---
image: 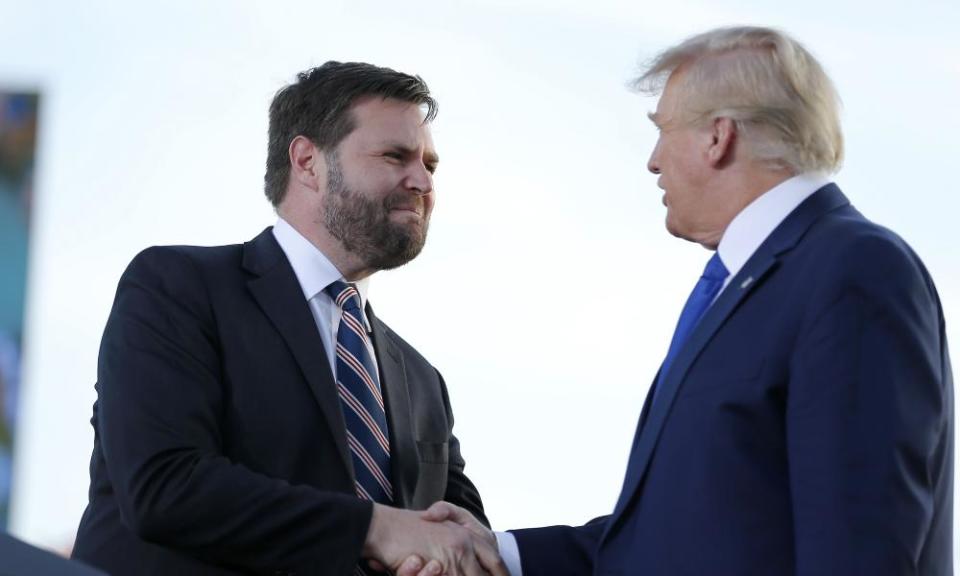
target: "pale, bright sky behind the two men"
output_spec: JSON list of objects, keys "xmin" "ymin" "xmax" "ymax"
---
[{"xmin": 0, "ymin": 0, "xmax": 960, "ymax": 564}]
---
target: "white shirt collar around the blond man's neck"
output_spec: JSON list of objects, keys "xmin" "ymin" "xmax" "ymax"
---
[{"xmin": 717, "ymin": 172, "xmax": 830, "ymax": 281}]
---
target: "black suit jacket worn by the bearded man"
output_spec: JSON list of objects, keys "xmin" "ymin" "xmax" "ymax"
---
[{"xmin": 74, "ymin": 229, "xmax": 486, "ymax": 576}]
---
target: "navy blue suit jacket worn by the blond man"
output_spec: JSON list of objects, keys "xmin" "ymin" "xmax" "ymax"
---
[{"xmin": 515, "ymin": 184, "xmax": 953, "ymax": 576}]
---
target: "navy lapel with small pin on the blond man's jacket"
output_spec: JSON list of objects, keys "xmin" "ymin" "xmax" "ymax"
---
[{"xmin": 607, "ymin": 184, "xmax": 849, "ymax": 533}]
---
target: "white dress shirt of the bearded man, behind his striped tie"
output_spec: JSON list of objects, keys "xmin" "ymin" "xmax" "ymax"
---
[{"xmin": 273, "ymin": 218, "xmax": 380, "ymax": 376}]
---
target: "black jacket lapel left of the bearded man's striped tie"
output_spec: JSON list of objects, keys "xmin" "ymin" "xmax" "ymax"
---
[{"xmin": 243, "ymin": 228, "xmax": 353, "ymax": 476}]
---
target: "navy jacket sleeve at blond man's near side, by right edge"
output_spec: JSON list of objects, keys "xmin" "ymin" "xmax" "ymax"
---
[{"xmin": 786, "ymin": 235, "xmax": 953, "ymax": 576}]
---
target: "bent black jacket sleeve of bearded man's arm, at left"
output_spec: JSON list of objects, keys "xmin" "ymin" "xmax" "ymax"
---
[{"xmin": 97, "ymin": 248, "xmax": 371, "ymax": 576}]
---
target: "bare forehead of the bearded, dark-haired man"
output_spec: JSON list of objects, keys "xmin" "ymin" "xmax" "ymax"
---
[{"xmin": 347, "ymin": 98, "xmax": 433, "ymax": 148}]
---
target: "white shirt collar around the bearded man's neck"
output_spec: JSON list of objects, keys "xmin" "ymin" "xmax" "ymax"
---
[{"xmin": 273, "ymin": 218, "xmax": 370, "ymax": 310}]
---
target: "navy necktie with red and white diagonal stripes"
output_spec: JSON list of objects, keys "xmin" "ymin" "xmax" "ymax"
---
[{"xmin": 326, "ymin": 280, "xmax": 393, "ymax": 504}]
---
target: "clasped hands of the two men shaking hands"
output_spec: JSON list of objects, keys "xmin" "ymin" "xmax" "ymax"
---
[{"xmin": 361, "ymin": 502, "xmax": 510, "ymax": 576}]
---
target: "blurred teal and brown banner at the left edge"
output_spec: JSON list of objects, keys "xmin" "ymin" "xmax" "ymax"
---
[{"xmin": 0, "ymin": 89, "xmax": 39, "ymax": 532}]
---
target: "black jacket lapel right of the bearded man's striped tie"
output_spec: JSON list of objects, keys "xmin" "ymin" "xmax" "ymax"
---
[{"xmin": 366, "ymin": 303, "xmax": 418, "ymax": 506}]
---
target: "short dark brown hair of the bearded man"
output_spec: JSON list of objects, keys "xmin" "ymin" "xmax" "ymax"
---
[{"xmin": 263, "ymin": 61, "xmax": 437, "ymax": 206}]
